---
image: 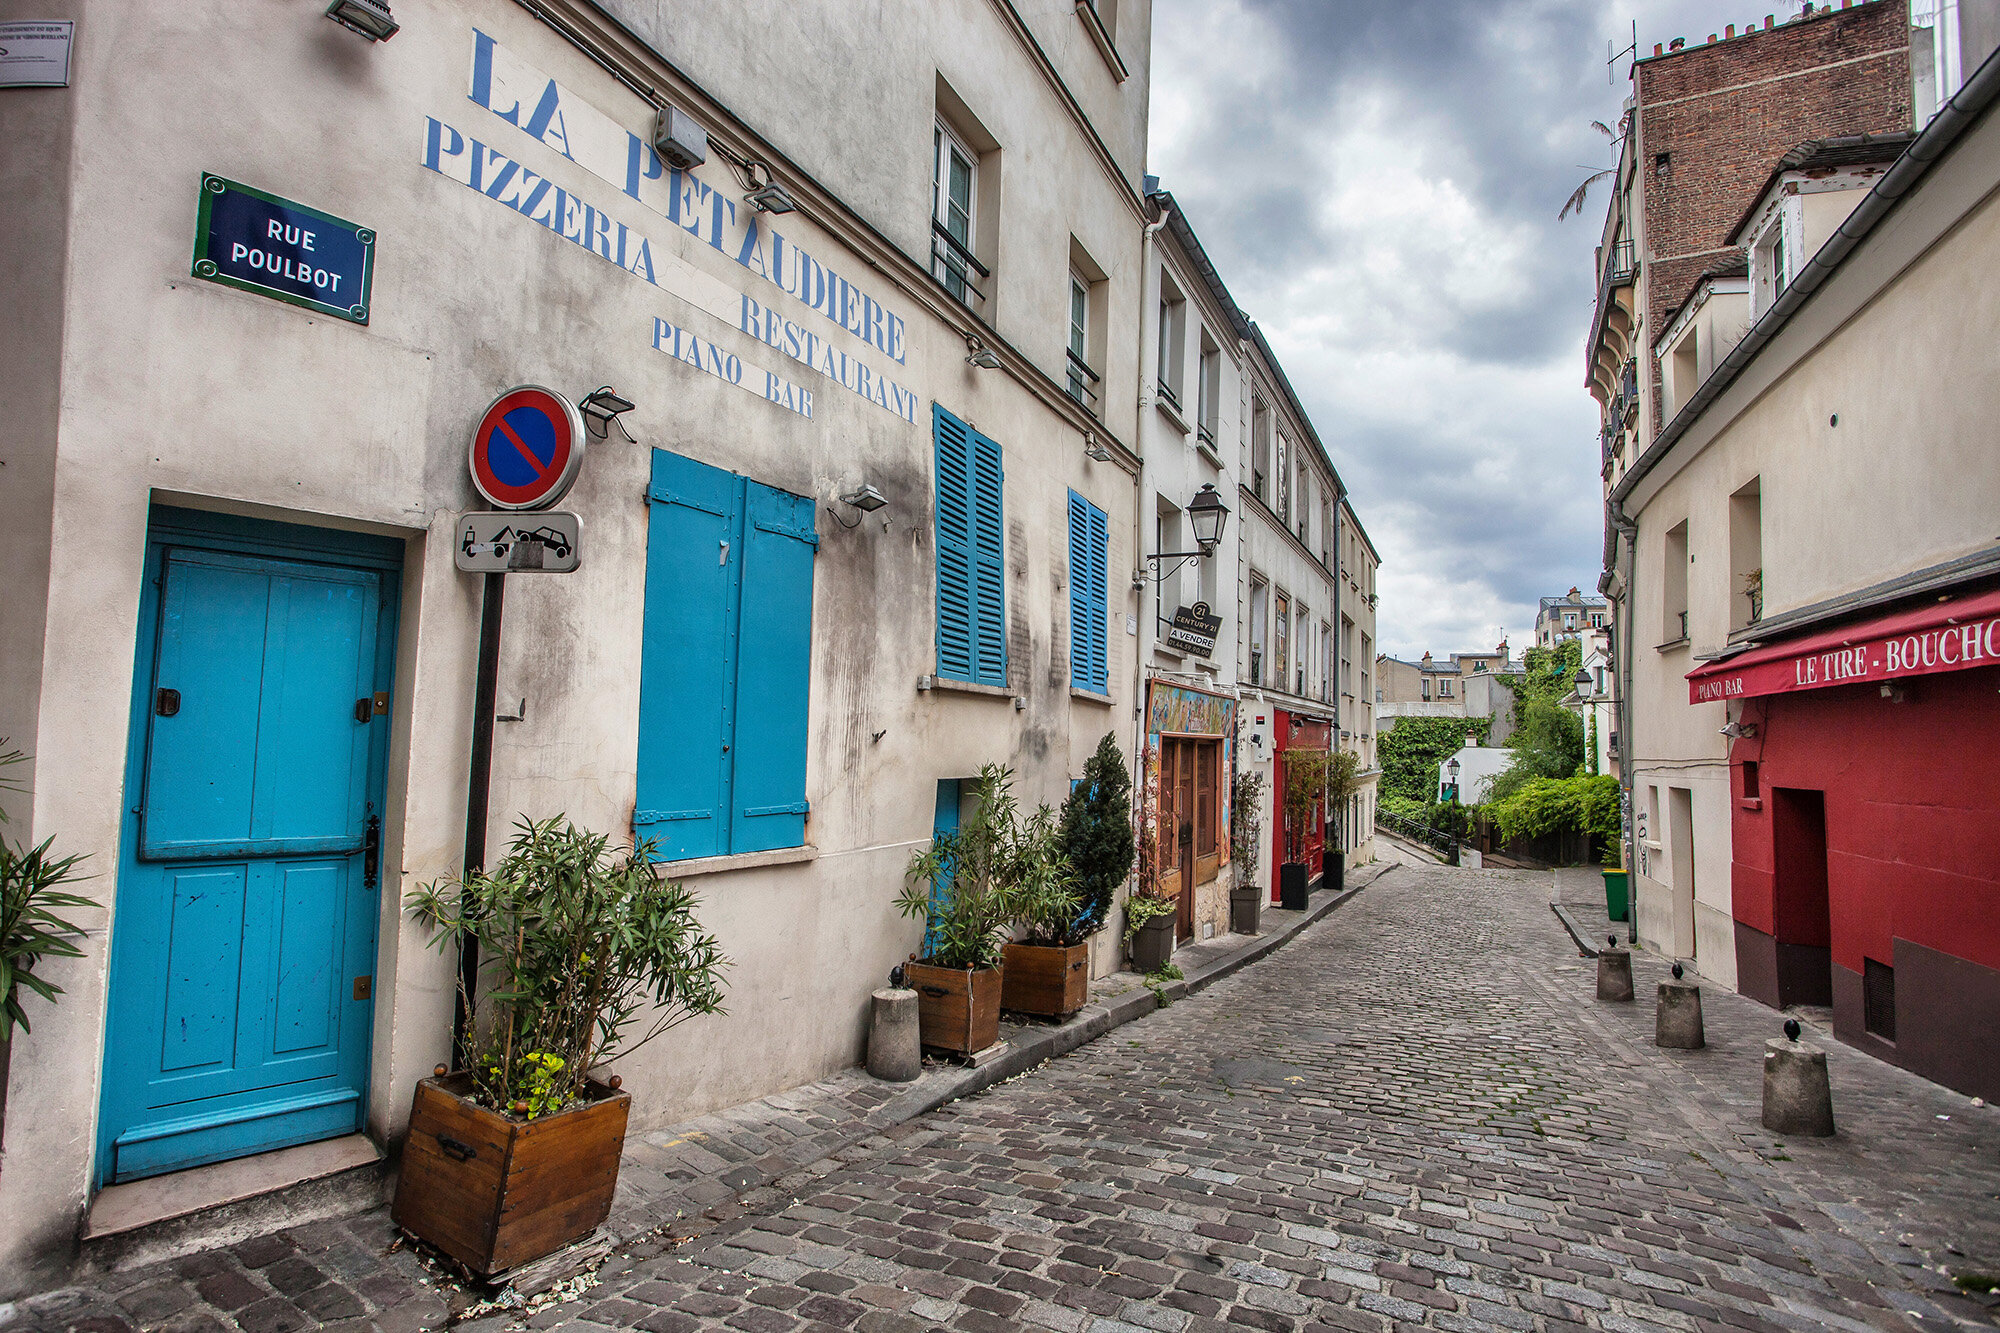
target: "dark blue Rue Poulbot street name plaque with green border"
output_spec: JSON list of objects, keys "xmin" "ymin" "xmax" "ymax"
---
[{"xmin": 194, "ymin": 172, "xmax": 374, "ymax": 324}]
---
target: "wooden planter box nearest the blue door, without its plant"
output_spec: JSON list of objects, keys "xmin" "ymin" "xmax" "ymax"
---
[{"xmin": 390, "ymin": 1075, "xmax": 632, "ymax": 1277}]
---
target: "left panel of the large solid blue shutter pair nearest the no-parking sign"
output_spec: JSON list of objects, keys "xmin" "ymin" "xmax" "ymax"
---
[{"xmin": 632, "ymin": 448, "xmax": 742, "ymax": 861}]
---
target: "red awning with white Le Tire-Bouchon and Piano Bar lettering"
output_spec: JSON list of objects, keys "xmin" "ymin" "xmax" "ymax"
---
[{"xmin": 1688, "ymin": 588, "xmax": 2000, "ymax": 703}]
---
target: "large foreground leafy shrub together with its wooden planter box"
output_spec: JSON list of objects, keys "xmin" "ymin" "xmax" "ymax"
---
[{"xmin": 392, "ymin": 815, "xmax": 728, "ymax": 1277}]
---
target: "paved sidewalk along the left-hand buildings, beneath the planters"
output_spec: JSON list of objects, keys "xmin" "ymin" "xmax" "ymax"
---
[{"xmin": 0, "ymin": 861, "xmax": 1398, "ymax": 1333}]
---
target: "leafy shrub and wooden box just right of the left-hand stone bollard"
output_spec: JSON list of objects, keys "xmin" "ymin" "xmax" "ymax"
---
[{"xmin": 912, "ymin": 765, "xmax": 1046, "ymax": 1057}]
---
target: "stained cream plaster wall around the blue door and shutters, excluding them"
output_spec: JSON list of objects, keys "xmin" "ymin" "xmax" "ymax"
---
[{"xmin": 0, "ymin": 0, "xmax": 1144, "ymax": 1295}]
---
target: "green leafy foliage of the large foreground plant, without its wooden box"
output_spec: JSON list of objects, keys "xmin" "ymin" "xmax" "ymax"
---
[{"xmin": 406, "ymin": 815, "xmax": 730, "ymax": 1119}]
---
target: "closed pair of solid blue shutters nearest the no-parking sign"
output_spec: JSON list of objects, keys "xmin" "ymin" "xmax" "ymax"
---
[{"xmin": 632, "ymin": 448, "xmax": 820, "ymax": 861}]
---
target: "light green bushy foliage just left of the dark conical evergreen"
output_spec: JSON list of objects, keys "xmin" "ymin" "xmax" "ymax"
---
[{"xmin": 896, "ymin": 765, "xmax": 1080, "ymax": 971}]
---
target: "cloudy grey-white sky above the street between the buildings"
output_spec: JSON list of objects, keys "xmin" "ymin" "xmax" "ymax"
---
[{"xmin": 1150, "ymin": 0, "xmax": 1796, "ymax": 656}]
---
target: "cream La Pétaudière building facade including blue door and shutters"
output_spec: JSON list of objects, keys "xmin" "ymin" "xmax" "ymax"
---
[{"xmin": 0, "ymin": 0, "xmax": 1152, "ymax": 1299}]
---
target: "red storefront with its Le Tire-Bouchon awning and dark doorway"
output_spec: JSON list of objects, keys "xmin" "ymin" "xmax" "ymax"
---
[{"xmin": 1688, "ymin": 586, "xmax": 2000, "ymax": 1099}]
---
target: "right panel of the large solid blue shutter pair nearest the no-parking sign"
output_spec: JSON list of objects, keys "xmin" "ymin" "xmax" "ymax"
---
[{"xmin": 730, "ymin": 480, "xmax": 820, "ymax": 853}]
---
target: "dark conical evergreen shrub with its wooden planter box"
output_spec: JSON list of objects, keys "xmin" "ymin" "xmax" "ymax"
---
[{"xmin": 1000, "ymin": 733, "xmax": 1134, "ymax": 1017}]
